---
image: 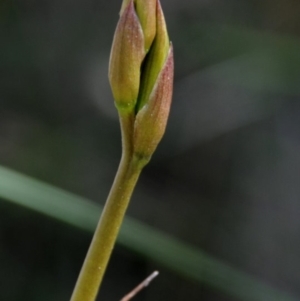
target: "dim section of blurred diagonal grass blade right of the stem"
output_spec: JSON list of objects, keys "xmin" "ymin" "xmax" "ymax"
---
[{"xmin": 119, "ymin": 219, "xmax": 298, "ymax": 301}]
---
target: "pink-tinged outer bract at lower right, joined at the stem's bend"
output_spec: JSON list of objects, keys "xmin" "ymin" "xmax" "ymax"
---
[{"xmin": 133, "ymin": 45, "xmax": 174, "ymax": 163}]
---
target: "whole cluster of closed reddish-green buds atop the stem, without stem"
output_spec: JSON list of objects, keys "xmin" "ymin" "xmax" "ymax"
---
[{"xmin": 109, "ymin": 0, "xmax": 174, "ymax": 163}]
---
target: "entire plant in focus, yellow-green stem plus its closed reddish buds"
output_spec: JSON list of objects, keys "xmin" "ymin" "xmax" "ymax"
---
[{"xmin": 71, "ymin": 0, "xmax": 174, "ymax": 301}]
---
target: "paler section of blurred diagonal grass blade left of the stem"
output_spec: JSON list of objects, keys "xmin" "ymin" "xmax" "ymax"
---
[{"xmin": 0, "ymin": 166, "xmax": 102, "ymax": 231}]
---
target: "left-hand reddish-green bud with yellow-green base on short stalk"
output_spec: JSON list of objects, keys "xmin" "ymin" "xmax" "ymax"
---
[{"xmin": 109, "ymin": 0, "xmax": 145, "ymax": 111}]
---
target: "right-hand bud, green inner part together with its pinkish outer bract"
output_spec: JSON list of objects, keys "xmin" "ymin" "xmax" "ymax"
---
[{"xmin": 133, "ymin": 1, "xmax": 174, "ymax": 161}]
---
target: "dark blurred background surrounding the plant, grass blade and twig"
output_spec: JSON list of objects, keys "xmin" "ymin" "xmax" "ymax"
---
[{"xmin": 0, "ymin": 0, "xmax": 300, "ymax": 301}]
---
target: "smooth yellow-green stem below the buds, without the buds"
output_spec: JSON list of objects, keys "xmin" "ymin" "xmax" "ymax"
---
[{"xmin": 71, "ymin": 114, "xmax": 142, "ymax": 301}]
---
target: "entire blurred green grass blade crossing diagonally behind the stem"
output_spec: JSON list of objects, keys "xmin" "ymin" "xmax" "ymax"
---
[{"xmin": 0, "ymin": 166, "xmax": 298, "ymax": 301}]
